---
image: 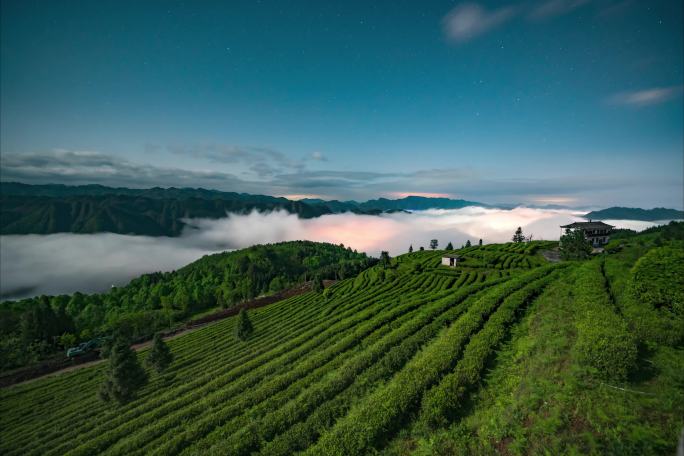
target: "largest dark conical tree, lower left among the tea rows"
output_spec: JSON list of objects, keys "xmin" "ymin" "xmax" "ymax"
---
[{"xmin": 99, "ymin": 338, "xmax": 148, "ymax": 404}]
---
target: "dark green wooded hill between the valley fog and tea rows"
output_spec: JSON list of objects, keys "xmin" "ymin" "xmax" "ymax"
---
[{"xmin": 0, "ymin": 241, "xmax": 373, "ymax": 370}]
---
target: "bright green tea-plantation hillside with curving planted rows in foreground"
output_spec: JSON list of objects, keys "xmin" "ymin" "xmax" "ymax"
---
[{"xmin": 0, "ymin": 225, "xmax": 684, "ymax": 455}]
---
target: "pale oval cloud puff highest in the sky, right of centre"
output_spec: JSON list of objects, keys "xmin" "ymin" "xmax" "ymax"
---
[{"xmin": 442, "ymin": 3, "xmax": 516, "ymax": 43}]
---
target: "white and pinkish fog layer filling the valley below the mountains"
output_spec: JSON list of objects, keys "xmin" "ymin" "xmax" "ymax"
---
[{"xmin": 0, "ymin": 207, "xmax": 654, "ymax": 299}]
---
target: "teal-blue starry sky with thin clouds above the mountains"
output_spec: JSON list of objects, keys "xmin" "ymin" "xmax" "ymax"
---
[{"xmin": 0, "ymin": 0, "xmax": 684, "ymax": 207}]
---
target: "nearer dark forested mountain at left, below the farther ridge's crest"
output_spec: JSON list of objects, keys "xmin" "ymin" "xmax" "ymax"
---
[{"xmin": 0, "ymin": 189, "xmax": 330, "ymax": 236}]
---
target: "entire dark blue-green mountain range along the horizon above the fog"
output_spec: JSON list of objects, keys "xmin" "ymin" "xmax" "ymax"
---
[{"xmin": 0, "ymin": 182, "xmax": 684, "ymax": 236}]
